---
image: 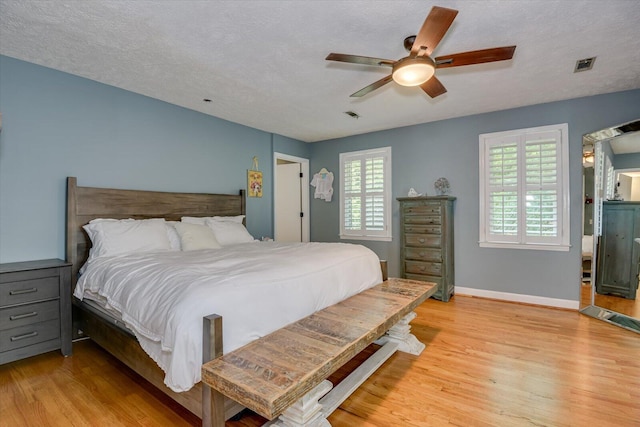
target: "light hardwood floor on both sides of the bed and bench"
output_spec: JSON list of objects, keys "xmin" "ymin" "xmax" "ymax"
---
[{"xmin": 0, "ymin": 296, "xmax": 640, "ymax": 427}]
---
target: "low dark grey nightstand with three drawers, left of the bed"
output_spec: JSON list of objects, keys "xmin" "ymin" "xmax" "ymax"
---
[{"xmin": 0, "ymin": 259, "xmax": 71, "ymax": 364}]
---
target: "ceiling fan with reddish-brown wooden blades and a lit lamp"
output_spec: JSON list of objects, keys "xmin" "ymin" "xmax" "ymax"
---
[{"xmin": 326, "ymin": 6, "xmax": 516, "ymax": 98}]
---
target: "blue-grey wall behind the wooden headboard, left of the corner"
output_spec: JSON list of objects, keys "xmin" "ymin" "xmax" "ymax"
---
[{"xmin": 0, "ymin": 56, "xmax": 307, "ymax": 262}]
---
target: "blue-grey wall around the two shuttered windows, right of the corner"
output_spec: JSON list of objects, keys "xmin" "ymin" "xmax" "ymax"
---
[{"xmin": 311, "ymin": 90, "xmax": 640, "ymax": 301}]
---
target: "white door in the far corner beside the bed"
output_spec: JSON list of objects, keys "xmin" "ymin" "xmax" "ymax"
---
[{"xmin": 274, "ymin": 163, "xmax": 302, "ymax": 242}]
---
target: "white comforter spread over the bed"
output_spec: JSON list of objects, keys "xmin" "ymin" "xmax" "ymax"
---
[{"xmin": 74, "ymin": 242, "xmax": 382, "ymax": 392}]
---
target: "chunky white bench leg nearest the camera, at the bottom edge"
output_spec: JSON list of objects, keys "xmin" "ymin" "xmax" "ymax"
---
[{"xmin": 269, "ymin": 380, "xmax": 333, "ymax": 427}]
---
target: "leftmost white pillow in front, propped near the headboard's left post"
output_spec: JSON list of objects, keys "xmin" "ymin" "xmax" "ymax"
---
[{"xmin": 83, "ymin": 218, "xmax": 171, "ymax": 259}]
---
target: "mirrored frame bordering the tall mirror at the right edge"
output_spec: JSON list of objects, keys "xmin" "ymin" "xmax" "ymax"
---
[{"xmin": 580, "ymin": 119, "xmax": 640, "ymax": 333}]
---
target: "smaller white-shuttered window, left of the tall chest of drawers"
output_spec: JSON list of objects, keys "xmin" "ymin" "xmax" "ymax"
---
[{"xmin": 340, "ymin": 147, "xmax": 391, "ymax": 241}]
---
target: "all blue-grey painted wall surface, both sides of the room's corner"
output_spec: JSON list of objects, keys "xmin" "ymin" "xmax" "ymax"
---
[{"xmin": 0, "ymin": 56, "xmax": 640, "ymax": 300}]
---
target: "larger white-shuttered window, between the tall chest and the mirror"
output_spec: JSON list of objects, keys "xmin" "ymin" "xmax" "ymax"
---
[{"xmin": 480, "ymin": 123, "xmax": 569, "ymax": 251}]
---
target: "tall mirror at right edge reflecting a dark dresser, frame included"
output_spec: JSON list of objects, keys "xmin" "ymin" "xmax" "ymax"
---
[{"xmin": 580, "ymin": 120, "xmax": 640, "ymax": 333}]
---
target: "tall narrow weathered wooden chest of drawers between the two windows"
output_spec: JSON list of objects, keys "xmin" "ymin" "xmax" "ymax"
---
[{"xmin": 397, "ymin": 196, "xmax": 456, "ymax": 301}]
